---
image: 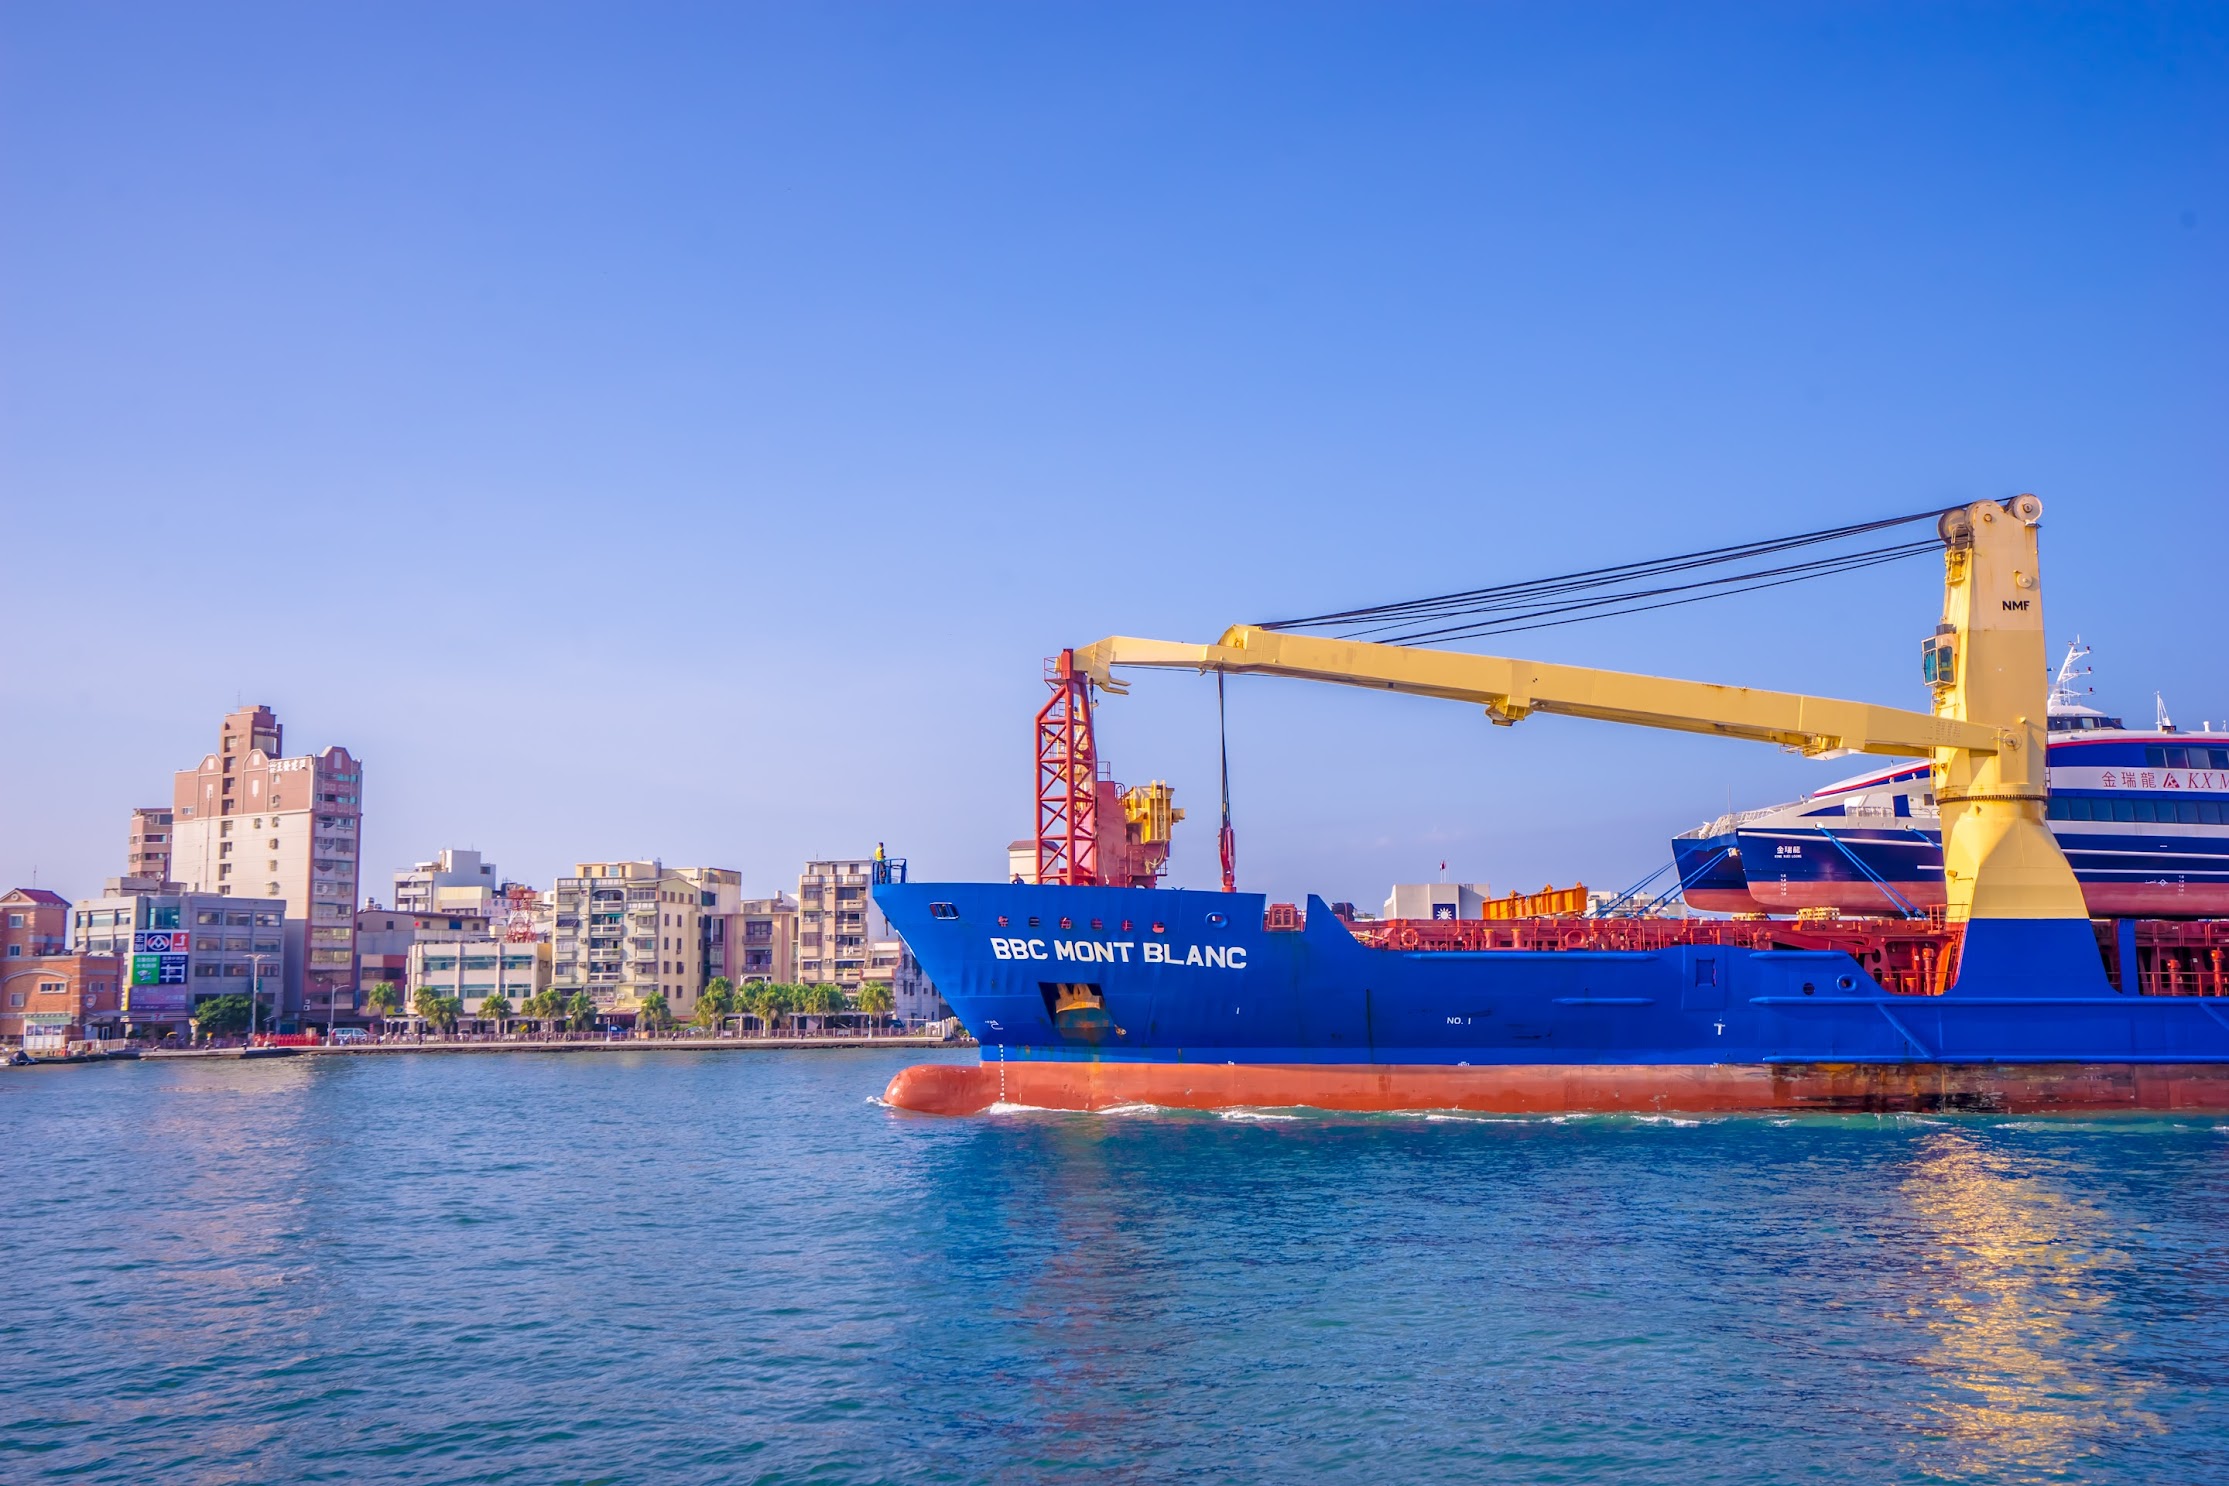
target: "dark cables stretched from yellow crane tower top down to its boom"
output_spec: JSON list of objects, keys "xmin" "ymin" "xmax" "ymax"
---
[{"xmin": 1259, "ymin": 510, "xmax": 1941, "ymax": 644}]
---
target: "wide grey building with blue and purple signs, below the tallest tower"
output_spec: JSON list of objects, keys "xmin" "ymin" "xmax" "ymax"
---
[{"xmin": 69, "ymin": 878, "xmax": 288, "ymax": 1036}]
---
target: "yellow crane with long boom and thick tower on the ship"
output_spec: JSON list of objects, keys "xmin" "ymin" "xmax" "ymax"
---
[{"xmin": 1074, "ymin": 495, "xmax": 2089, "ymax": 922}]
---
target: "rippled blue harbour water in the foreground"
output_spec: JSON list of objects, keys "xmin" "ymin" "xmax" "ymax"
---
[{"xmin": 0, "ymin": 1052, "xmax": 2229, "ymax": 1484}]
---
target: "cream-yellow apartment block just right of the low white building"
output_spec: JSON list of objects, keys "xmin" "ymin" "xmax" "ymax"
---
[{"xmin": 553, "ymin": 860, "xmax": 718, "ymax": 1020}]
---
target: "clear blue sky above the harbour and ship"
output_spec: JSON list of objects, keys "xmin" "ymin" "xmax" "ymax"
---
[{"xmin": 0, "ymin": 0, "xmax": 2229, "ymax": 902}]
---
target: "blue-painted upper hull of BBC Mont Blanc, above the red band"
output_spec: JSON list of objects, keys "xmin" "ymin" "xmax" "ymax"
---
[{"xmin": 874, "ymin": 882, "xmax": 2229, "ymax": 1065}]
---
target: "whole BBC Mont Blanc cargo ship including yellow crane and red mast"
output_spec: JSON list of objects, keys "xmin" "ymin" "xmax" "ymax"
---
[{"xmin": 874, "ymin": 495, "xmax": 2229, "ymax": 1112}]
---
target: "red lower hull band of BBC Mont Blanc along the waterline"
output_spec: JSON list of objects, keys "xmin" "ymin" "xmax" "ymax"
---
[{"xmin": 883, "ymin": 1060, "xmax": 2229, "ymax": 1114}]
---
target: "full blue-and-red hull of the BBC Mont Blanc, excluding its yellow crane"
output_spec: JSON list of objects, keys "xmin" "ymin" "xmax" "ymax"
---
[{"xmin": 874, "ymin": 882, "xmax": 2229, "ymax": 1112}]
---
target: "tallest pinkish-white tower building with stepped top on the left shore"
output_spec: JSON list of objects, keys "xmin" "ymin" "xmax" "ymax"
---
[{"xmin": 169, "ymin": 706, "xmax": 363, "ymax": 1025}]
